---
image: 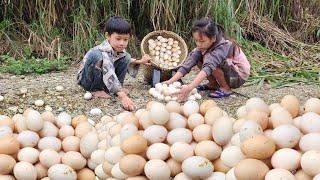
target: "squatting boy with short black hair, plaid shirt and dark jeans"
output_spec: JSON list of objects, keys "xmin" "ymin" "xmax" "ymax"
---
[{"xmin": 77, "ymin": 17, "xmax": 150, "ymax": 111}]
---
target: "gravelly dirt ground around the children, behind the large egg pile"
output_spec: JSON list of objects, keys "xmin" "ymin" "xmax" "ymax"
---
[{"xmin": 0, "ymin": 67, "xmax": 320, "ymax": 120}]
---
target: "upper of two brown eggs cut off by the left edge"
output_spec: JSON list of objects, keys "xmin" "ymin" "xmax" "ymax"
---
[{"xmin": 0, "ymin": 136, "xmax": 20, "ymax": 155}]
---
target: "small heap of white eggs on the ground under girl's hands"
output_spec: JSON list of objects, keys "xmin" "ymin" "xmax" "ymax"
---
[{"xmin": 149, "ymin": 82, "xmax": 202, "ymax": 102}]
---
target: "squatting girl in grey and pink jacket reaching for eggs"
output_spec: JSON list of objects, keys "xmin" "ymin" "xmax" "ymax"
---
[{"xmin": 164, "ymin": 17, "xmax": 250, "ymax": 100}]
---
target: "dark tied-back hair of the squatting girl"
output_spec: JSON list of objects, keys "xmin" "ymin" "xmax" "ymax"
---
[{"xmin": 191, "ymin": 17, "xmax": 224, "ymax": 38}]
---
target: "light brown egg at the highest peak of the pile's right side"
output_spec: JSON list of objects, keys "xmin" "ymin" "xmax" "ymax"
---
[{"xmin": 280, "ymin": 95, "xmax": 300, "ymax": 118}]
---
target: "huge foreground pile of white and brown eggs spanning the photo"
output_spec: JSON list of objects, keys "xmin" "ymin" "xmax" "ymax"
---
[{"xmin": 0, "ymin": 95, "xmax": 320, "ymax": 180}]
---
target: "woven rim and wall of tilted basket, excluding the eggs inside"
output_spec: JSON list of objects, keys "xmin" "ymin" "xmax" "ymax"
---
[{"xmin": 141, "ymin": 30, "xmax": 188, "ymax": 71}]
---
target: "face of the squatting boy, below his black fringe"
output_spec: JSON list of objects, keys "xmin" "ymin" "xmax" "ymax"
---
[{"xmin": 107, "ymin": 33, "xmax": 130, "ymax": 52}]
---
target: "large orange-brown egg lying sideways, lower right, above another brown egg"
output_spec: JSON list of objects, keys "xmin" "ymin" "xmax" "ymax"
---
[{"xmin": 241, "ymin": 135, "xmax": 276, "ymax": 159}]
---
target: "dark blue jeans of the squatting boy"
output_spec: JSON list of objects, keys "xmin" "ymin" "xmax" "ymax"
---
[{"xmin": 79, "ymin": 50, "xmax": 131, "ymax": 92}]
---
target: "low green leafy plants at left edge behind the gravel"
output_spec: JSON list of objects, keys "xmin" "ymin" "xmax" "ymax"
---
[{"xmin": 0, "ymin": 55, "xmax": 70, "ymax": 75}]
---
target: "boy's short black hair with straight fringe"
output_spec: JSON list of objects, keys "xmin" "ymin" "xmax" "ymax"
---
[{"xmin": 104, "ymin": 16, "xmax": 131, "ymax": 35}]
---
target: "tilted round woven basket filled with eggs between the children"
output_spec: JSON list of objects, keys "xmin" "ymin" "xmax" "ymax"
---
[{"xmin": 141, "ymin": 30, "xmax": 188, "ymax": 71}]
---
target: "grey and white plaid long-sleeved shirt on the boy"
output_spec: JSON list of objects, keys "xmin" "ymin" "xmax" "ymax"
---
[{"xmin": 78, "ymin": 40, "xmax": 139, "ymax": 94}]
